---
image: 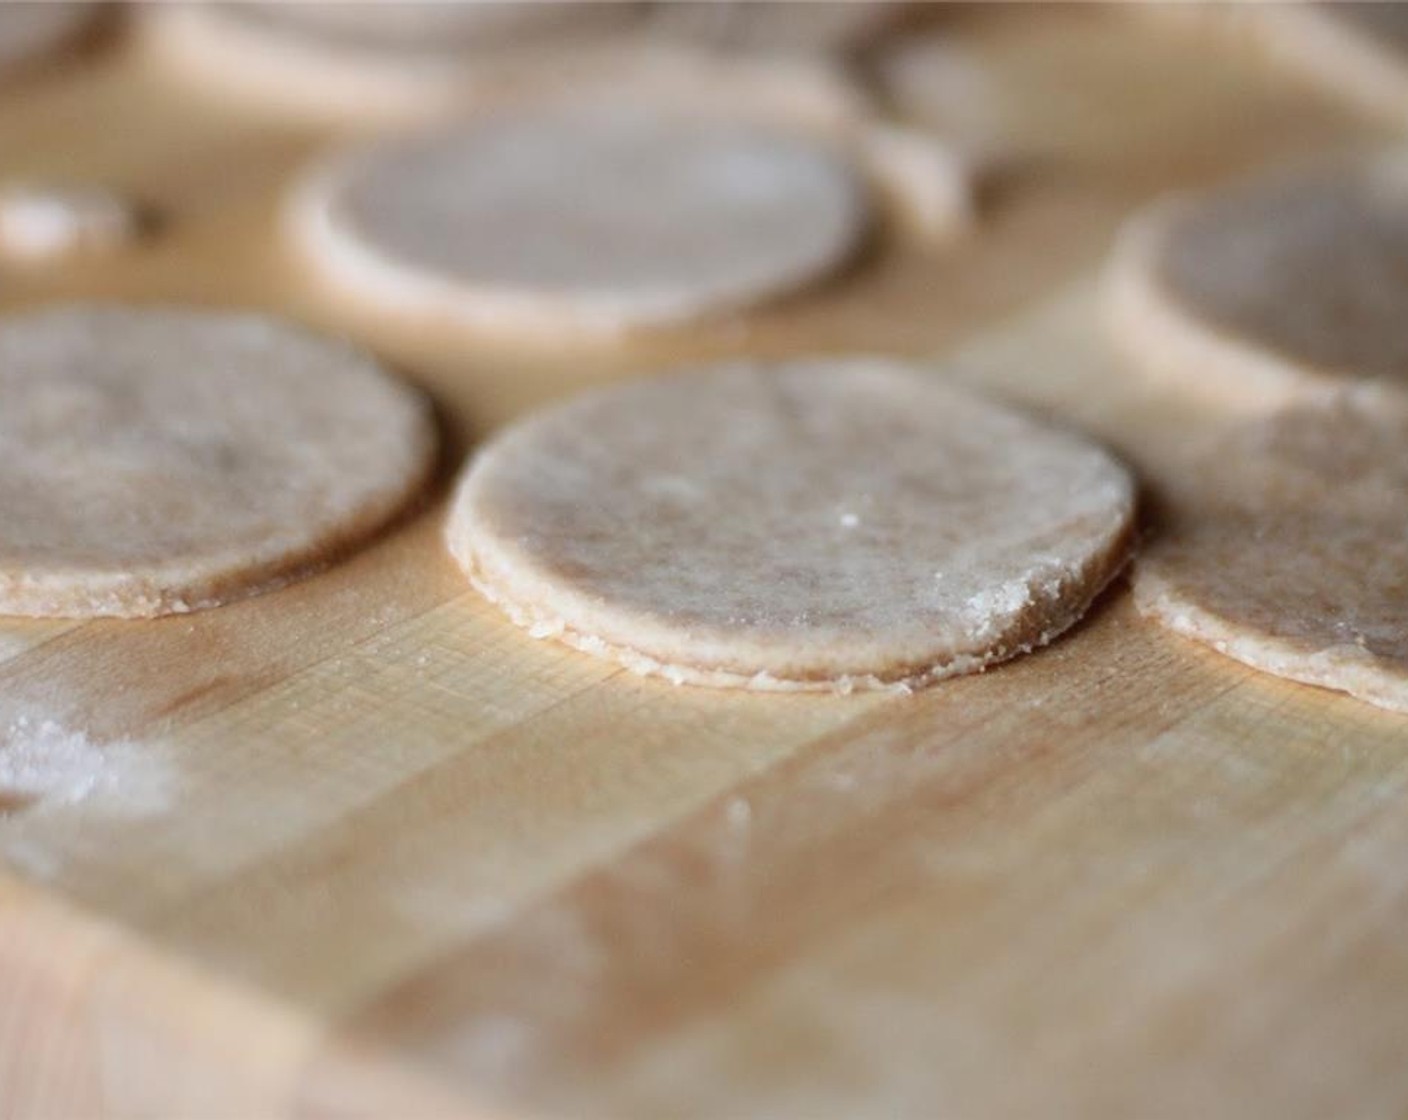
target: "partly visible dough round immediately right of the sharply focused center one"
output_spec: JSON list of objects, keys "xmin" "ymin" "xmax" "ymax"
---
[{"xmin": 1135, "ymin": 386, "xmax": 1408, "ymax": 711}]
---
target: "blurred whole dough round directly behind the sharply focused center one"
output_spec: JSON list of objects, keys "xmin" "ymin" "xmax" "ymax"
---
[{"xmin": 291, "ymin": 106, "xmax": 869, "ymax": 330}]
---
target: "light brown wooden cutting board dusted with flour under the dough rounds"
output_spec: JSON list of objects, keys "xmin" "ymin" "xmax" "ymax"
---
[{"xmin": 0, "ymin": 7, "xmax": 1408, "ymax": 1120}]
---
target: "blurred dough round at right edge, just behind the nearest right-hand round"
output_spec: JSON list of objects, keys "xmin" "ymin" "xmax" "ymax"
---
[{"xmin": 1107, "ymin": 158, "xmax": 1408, "ymax": 406}]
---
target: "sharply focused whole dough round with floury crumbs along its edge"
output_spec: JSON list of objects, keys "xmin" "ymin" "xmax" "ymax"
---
[{"xmin": 446, "ymin": 359, "xmax": 1133, "ymax": 692}]
